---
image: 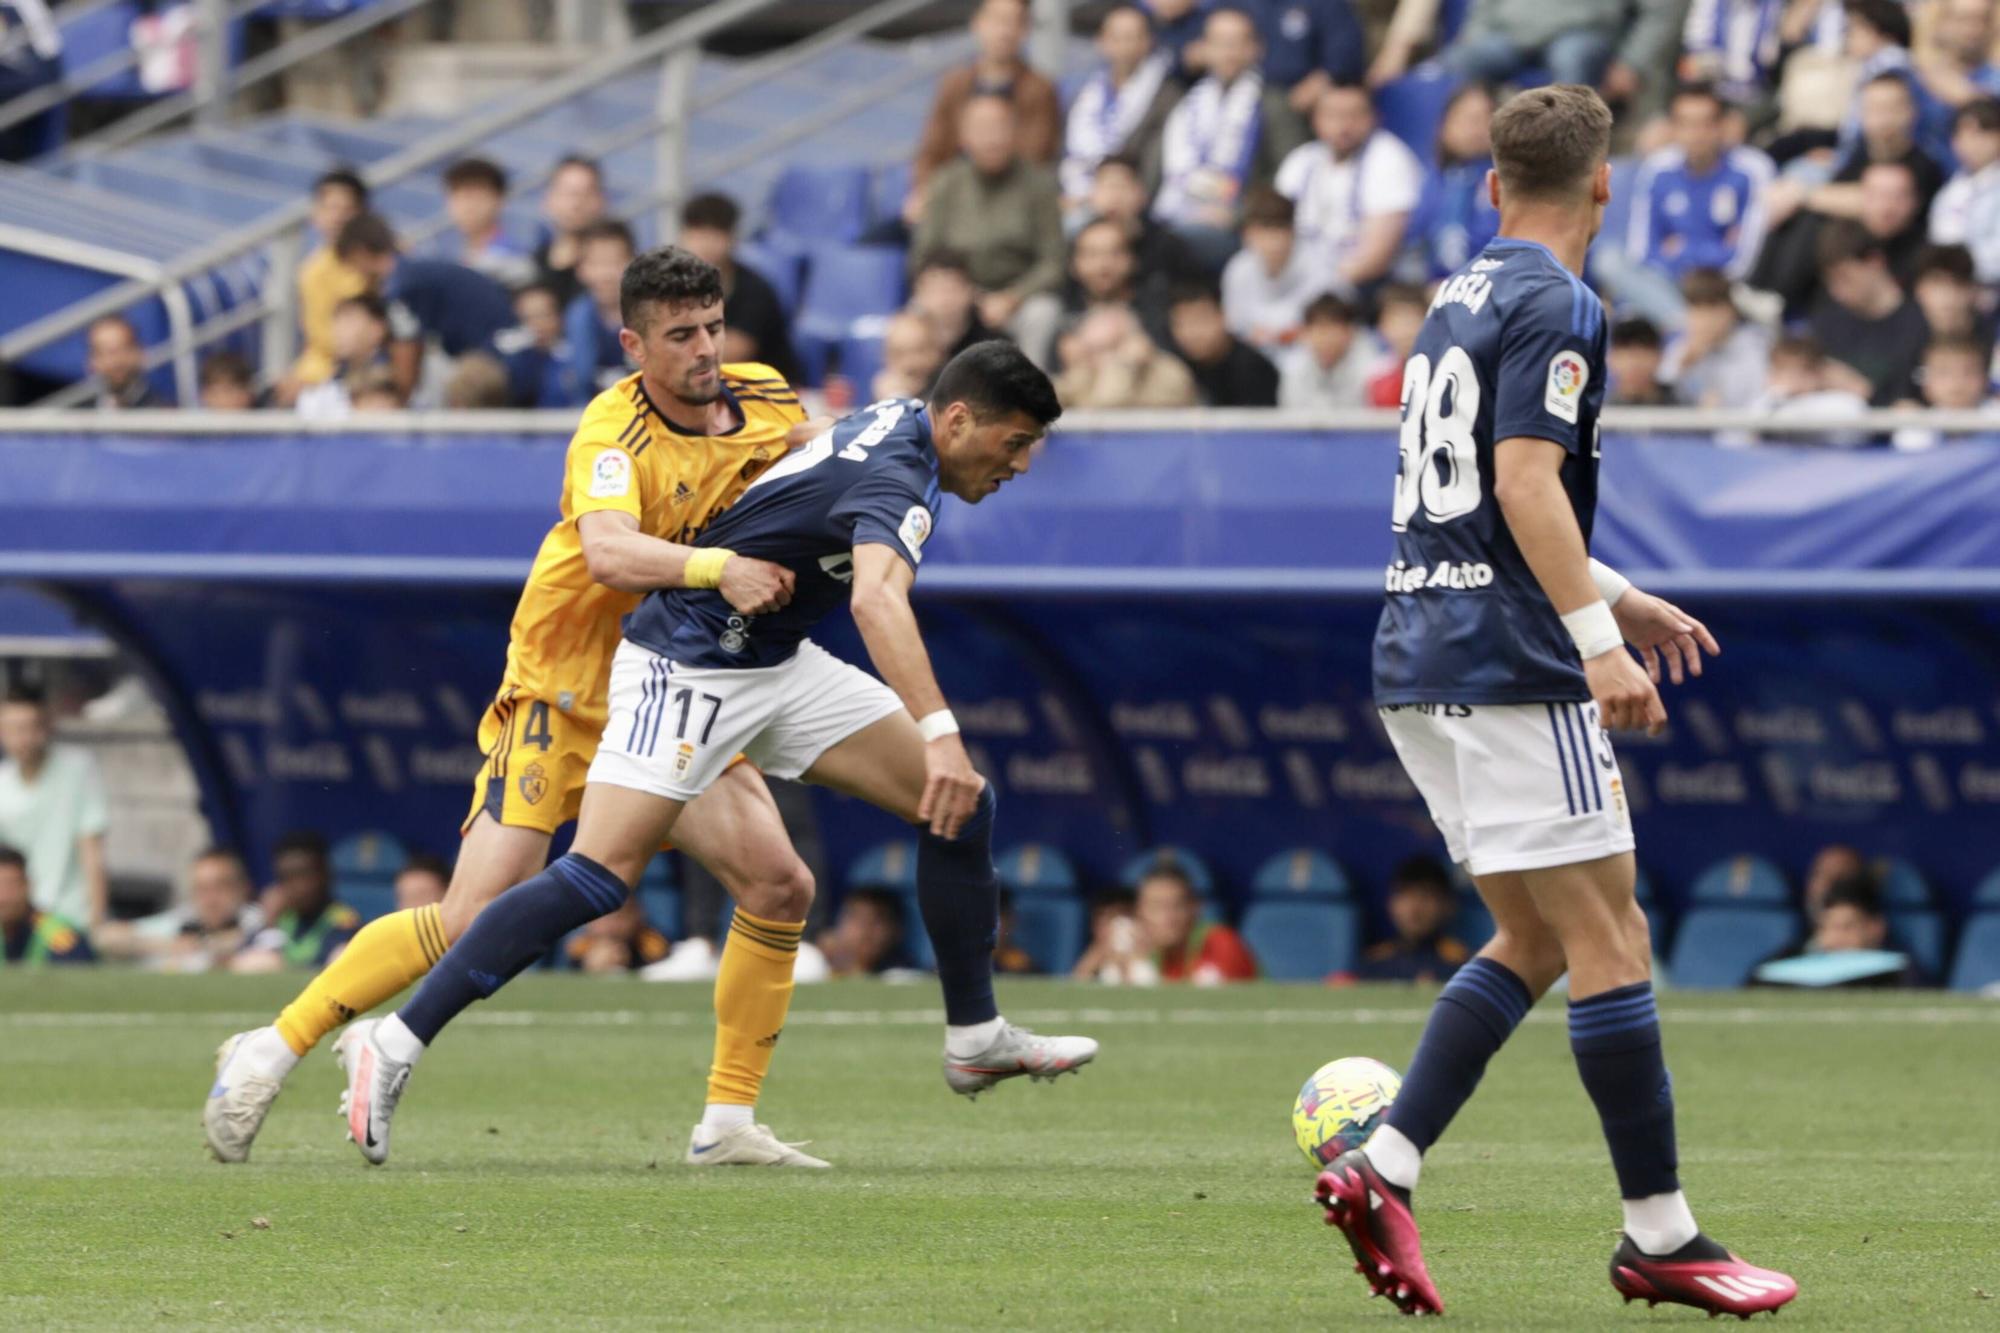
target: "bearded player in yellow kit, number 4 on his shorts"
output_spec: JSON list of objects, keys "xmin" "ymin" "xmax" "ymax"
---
[{"xmin": 215, "ymin": 248, "xmax": 826, "ymax": 1167}]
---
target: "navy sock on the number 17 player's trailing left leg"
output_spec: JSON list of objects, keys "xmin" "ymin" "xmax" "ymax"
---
[{"xmin": 396, "ymin": 853, "xmax": 626, "ymax": 1047}]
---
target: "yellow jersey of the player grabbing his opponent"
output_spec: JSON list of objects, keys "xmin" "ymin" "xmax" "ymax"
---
[{"xmin": 502, "ymin": 362, "xmax": 806, "ymax": 731}]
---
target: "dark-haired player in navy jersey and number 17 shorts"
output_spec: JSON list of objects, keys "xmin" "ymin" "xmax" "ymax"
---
[{"xmin": 348, "ymin": 342, "xmax": 1098, "ymax": 1161}]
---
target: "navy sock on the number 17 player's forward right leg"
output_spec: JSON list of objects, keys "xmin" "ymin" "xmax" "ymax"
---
[{"xmin": 916, "ymin": 783, "xmax": 1000, "ymax": 1027}]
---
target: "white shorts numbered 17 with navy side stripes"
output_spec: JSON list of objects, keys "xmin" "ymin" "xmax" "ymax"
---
[{"xmin": 590, "ymin": 638, "xmax": 902, "ymax": 801}]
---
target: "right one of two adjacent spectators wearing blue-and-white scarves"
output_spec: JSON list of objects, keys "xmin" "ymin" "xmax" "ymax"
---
[{"xmin": 1150, "ymin": 8, "xmax": 1300, "ymax": 272}]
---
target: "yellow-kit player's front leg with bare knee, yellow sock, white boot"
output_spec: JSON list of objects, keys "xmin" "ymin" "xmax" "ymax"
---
[{"xmin": 674, "ymin": 765, "xmax": 826, "ymax": 1167}]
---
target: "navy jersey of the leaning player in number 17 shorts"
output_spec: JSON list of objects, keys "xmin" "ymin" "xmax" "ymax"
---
[{"xmin": 626, "ymin": 398, "xmax": 938, "ymax": 667}]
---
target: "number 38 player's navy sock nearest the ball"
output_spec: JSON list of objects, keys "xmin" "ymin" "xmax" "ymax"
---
[{"xmin": 1384, "ymin": 957, "xmax": 1534, "ymax": 1153}]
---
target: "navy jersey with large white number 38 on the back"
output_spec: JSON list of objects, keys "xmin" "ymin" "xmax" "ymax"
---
[{"xmin": 1374, "ymin": 236, "xmax": 1604, "ymax": 705}]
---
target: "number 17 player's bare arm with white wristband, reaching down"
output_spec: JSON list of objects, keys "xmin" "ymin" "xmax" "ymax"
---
[{"xmin": 850, "ymin": 540, "xmax": 986, "ymax": 839}]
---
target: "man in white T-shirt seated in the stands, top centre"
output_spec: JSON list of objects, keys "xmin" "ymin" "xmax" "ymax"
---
[{"xmin": 1278, "ymin": 84, "xmax": 1424, "ymax": 296}]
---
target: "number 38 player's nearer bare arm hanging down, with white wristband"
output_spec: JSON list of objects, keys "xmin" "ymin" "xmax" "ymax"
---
[{"xmin": 1494, "ymin": 436, "xmax": 1666, "ymax": 735}]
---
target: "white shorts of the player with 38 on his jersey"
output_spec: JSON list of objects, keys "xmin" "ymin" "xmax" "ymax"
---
[{"xmin": 1380, "ymin": 703, "xmax": 1632, "ymax": 875}]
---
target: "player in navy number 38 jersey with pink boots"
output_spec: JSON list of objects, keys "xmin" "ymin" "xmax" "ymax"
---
[{"xmin": 1316, "ymin": 86, "xmax": 1798, "ymax": 1319}]
